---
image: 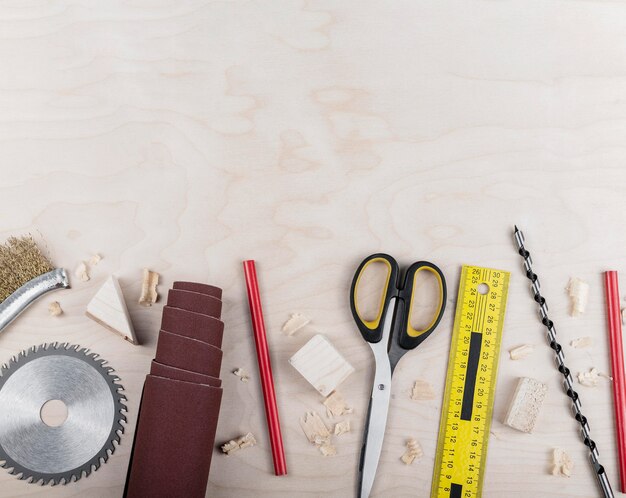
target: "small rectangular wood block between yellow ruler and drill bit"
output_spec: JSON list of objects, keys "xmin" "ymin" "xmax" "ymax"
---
[{"xmin": 504, "ymin": 377, "xmax": 548, "ymax": 433}]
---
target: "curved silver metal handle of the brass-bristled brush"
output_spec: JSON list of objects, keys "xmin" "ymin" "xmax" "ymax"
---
[{"xmin": 0, "ymin": 268, "xmax": 70, "ymax": 331}]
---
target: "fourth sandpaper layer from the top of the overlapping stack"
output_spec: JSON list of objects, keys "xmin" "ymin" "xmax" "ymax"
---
[{"xmin": 155, "ymin": 330, "xmax": 222, "ymax": 377}]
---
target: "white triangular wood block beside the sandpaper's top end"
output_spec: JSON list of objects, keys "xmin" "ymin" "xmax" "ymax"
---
[{"xmin": 85, "ymin": 275, "xmax": 137, "ymax": 344}]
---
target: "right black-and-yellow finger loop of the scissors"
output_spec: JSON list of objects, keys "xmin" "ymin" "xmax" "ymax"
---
[{"xmin": 398, "ymin": 261, "xmax": 447, "ymax": 349}]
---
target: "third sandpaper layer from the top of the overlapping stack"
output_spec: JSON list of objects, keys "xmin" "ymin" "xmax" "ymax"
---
[{"xmin": 161, "ymin": 306, "xmax": 224, "ymax": 348}]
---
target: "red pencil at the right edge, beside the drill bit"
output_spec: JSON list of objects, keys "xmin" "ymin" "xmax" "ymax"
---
[{"xmin": 604, "ymin": 271, "xmax": 626, "ymax": 493}]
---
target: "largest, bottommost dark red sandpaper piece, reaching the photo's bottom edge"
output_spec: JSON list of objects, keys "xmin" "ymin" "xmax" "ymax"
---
[{"xmin": 124, "ymin": 375, "xmax": 222, "ymax": 498}]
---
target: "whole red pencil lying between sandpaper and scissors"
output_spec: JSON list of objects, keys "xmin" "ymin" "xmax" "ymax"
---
[{"xmin": 243, "ymin": 260, "xmax": 287, "ymax": 476}]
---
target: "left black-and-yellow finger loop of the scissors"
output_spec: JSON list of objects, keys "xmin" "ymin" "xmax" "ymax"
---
[{"xmin": 350, "ymin": 253, "xmax": 399, "ymax": 342}]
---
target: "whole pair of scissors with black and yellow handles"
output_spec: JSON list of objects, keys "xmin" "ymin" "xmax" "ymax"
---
[{"xmin": 350, "ymin": 253, "xmax": 446, "ymax": 498}]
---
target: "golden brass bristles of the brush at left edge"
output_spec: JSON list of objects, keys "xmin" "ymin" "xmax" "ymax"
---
[{"xmin": 0, "ymin": 235, "xmax": 54, "ymax": 303}]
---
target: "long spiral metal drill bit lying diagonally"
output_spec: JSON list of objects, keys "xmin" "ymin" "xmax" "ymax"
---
[{"xmin": 515, "ymin": 226, "xmax": 614, "ymax": 498}]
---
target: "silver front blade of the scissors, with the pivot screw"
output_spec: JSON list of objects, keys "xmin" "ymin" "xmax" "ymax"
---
[{"xmin": 359, "ymin": 299, "xmax": 396, "ymax": 498}]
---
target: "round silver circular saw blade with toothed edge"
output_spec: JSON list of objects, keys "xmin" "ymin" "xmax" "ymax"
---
[{"xmin": 0, "ymin": 343, "xmax": 126, "ymax": 485}]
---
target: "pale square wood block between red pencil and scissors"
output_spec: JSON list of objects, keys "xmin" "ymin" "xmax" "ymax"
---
[{"xmin": 289, "ymin": 334, "xmax": 354, "ymax": 396}]
